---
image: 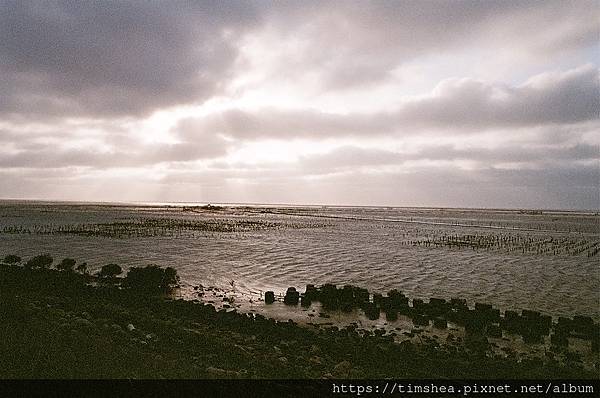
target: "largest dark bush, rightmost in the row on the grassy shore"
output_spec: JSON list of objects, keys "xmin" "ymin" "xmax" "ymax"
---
[{"xmin": 123, "ymin": 265, "xmax": 179, "ymax": 292}]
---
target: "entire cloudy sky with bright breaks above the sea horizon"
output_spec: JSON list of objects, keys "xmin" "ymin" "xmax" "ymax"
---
[{"xmin": 0, "ymin": 0, "xmax": 600, "ymax": 210}]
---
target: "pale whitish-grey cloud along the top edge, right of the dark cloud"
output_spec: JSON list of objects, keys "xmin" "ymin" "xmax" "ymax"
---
[{"xmin": 256, "ymin": 0, "xmax": 599, "ymax": 90}]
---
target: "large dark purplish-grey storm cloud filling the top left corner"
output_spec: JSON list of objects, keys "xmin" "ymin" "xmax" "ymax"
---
[{"xmin": 0, "ymin": 1, "xmax": 257, "ymax": 116}]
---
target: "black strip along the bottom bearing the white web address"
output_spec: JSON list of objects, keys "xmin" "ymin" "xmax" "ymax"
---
[{"xmin": 0, "ymin": 378, "xmax": 600, "ymax": 398}]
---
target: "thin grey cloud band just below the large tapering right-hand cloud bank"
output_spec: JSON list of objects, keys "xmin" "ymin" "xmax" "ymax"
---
[{"xmin": 156, "ymin": 139, "xmax": 600, "ymax": 182}]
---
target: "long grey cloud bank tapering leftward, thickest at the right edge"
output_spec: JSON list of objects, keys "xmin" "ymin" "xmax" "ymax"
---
[{"xmin": 179, "ymin": 65, "xmax": 600, "ymax": 139}]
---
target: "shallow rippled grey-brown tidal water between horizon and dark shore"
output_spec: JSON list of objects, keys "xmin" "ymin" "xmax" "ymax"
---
[{"xmin": 0, "ymin": 201, "xmax": 600, "ymax": 321}]
